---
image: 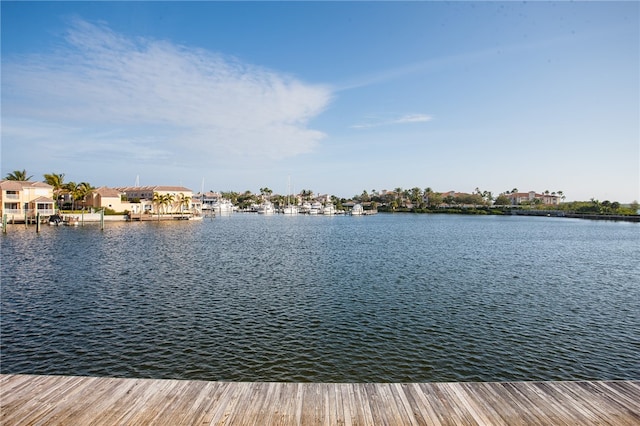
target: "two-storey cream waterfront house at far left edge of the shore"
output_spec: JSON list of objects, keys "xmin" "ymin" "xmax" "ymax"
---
[{"xmin": 0, "ymin": 180, "xmax": 55, "ymax": 221}]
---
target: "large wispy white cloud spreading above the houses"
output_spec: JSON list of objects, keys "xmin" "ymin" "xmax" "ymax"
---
[{"xmin": 2, "ymin": 19, "xmax": 332, "ymax": 166}]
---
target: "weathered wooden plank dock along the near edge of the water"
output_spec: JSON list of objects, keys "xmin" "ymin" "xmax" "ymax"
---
[{"xmin": 0, "ymin": 374, "xmax": 640, "ymax": 426}]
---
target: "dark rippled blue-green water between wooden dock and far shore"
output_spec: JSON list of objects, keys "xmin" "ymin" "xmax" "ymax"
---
[{"xmin": 0, "ymin": 214, "xmax": 640, "ymax": 382}]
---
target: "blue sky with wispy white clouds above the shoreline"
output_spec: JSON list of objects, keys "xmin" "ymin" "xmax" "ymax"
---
[{"xmin": 1, "ymin": 1, "xmax": 640, "ymax": 203}]
